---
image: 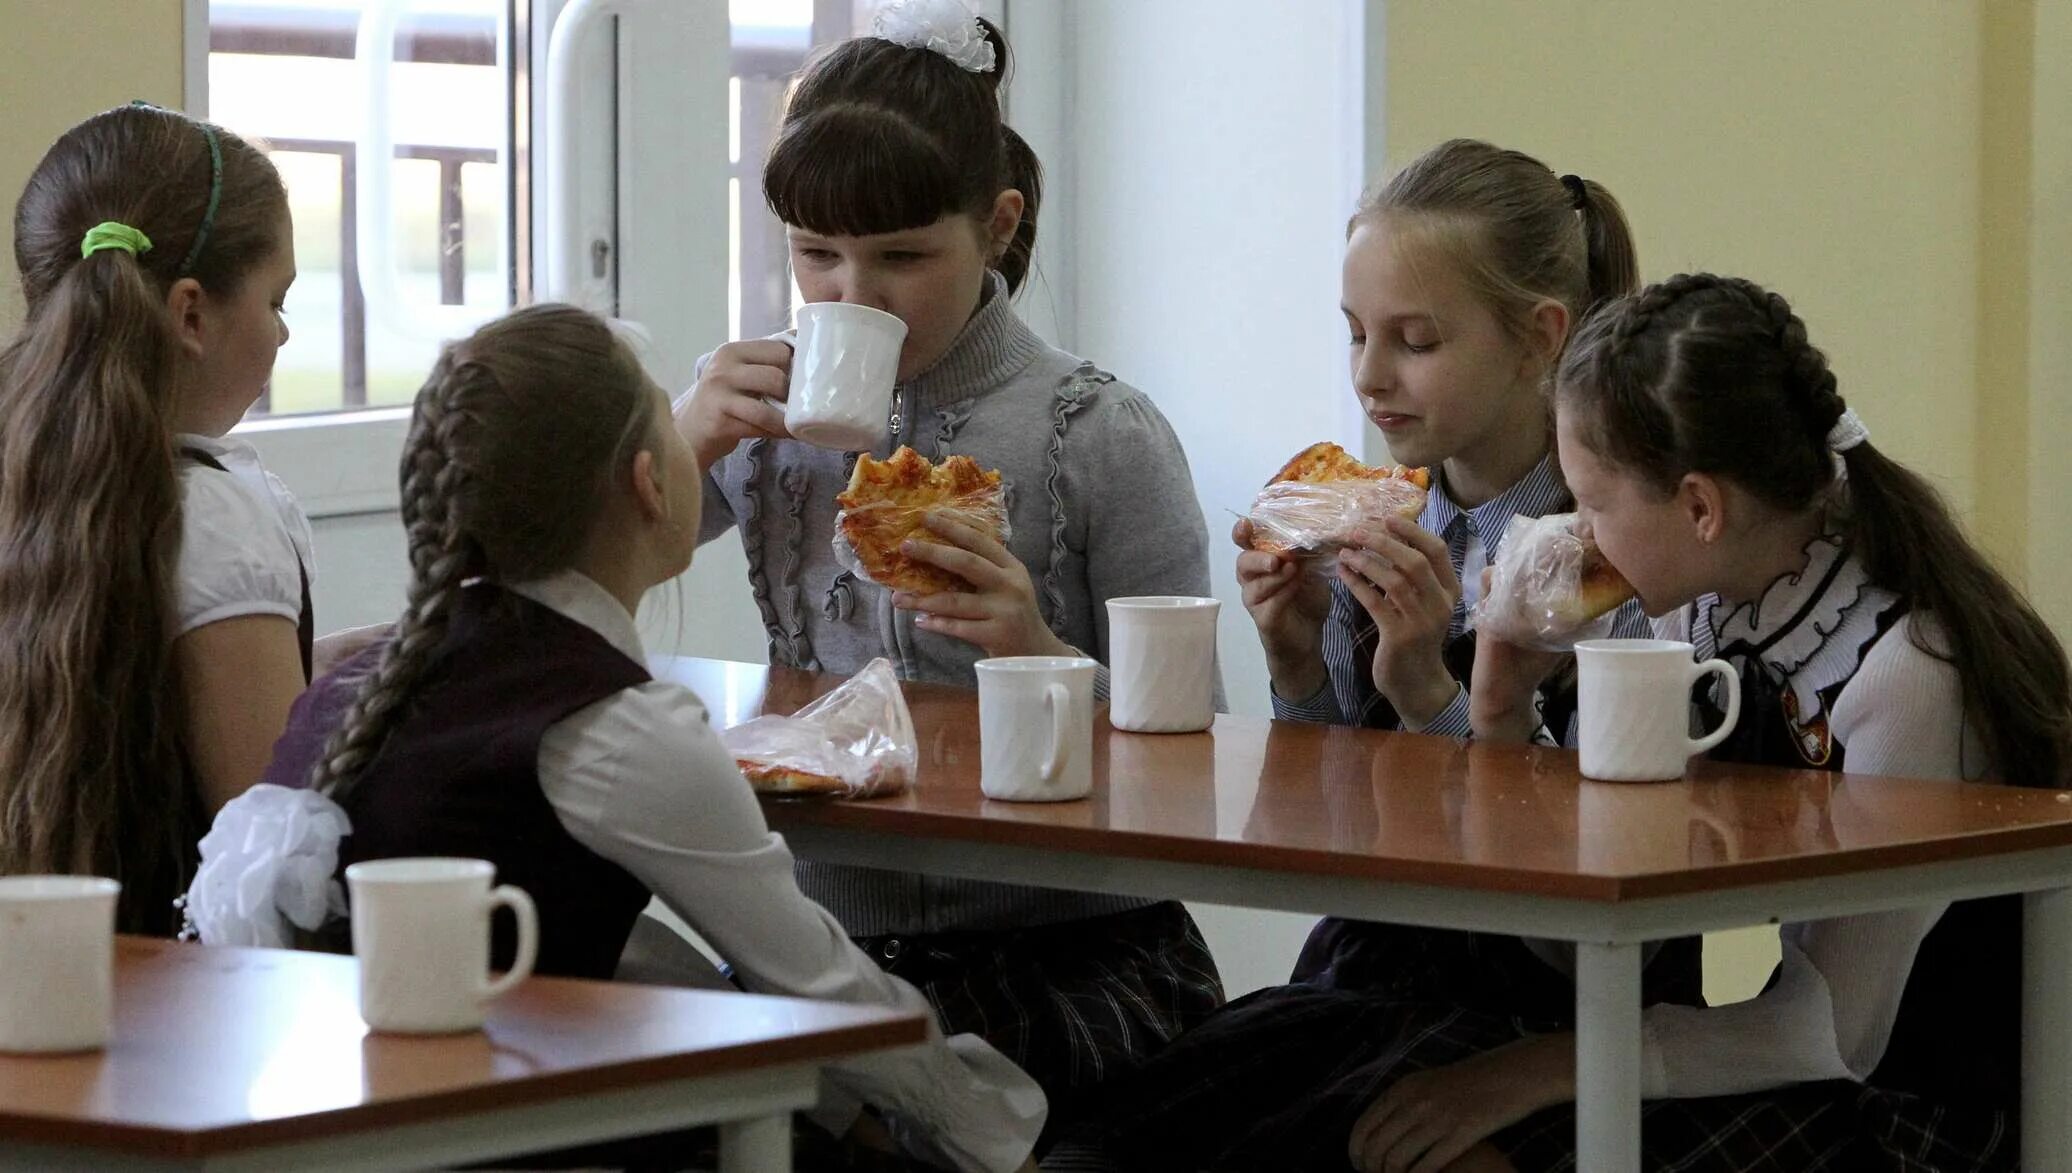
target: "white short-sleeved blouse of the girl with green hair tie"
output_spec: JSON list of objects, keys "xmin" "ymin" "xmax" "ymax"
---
[{"xmin": 174, "ymin": 435, "xmax": 315, "ymax": 636}]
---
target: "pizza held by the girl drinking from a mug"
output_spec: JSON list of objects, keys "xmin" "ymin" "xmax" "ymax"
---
[{"xmin": 835, "ymin": 448, "xmax": 1007, "ymax": 595}]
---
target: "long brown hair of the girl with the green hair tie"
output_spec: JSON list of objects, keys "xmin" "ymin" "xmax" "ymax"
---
[{"xmin": 0, "ymin": 108, "xmax": 288, "ymax": 933}]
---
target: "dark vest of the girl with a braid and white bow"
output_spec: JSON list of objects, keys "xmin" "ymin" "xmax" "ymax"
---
[{"xmin": 265, "ymin": 582, "xmax": 649, "ymax": 978}]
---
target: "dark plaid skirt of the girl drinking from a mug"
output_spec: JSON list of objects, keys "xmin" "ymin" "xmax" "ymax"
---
[{"xmin": 856, "ymin": 902, "xmax": 1222, "ymax": 1138}]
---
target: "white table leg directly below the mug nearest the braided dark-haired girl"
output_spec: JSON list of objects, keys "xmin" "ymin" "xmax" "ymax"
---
[{"xmin": 1575, "ymin": 941, "xmax": 1641, "ymax": 1173}]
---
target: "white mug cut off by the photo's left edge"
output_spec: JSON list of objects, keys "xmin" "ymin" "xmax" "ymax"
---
[{"xmin": 0, "ymin": 877, "xmax": 122, "ymax": 1053}]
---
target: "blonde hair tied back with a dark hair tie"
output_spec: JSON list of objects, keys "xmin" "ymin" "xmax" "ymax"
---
[{"xmin": 1347, "ymin": 139, "xmax": 1641, "ymax": 336}]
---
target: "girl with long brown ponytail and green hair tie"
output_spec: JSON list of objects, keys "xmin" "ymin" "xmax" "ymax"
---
[{"xmin": 0, "ymin": 104, "xmax": 368, "ymax": 933}]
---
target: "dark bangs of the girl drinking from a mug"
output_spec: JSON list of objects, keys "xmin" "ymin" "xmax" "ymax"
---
[{"xmin": 762, "ymin": 104, "xmax": 977, "ymax": 236}]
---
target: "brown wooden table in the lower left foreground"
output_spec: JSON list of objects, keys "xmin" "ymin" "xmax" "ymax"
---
[{"xmin": 0, "ymin": 937, "xmax": 926, "ymax": 1173}]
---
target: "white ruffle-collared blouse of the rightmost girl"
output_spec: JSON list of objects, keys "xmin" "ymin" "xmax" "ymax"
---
[{"xmin": 1641, "ymin": 543, "xmax": 1987, "ymax": 1098}]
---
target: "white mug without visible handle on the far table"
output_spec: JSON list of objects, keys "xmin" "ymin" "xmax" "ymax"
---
[{"xmin": 1109, "ymin": 595, "xmax": 1222, "ymax": 734}]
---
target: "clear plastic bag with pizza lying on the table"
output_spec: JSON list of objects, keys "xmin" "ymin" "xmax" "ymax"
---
[{"xmin": 719, "ymin": 659, "xmax": 920, "ymax": 798}]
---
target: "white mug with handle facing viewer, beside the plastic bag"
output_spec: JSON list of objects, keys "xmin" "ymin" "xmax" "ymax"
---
[{"xmin": 978, "ymin": 655, "xmax": 1098, "ymax": 802}]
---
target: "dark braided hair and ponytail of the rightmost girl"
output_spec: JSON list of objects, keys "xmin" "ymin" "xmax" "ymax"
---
[{"xmin": 1554, "ymin": 274, "xmax": 2072, "ymax": 788}]
